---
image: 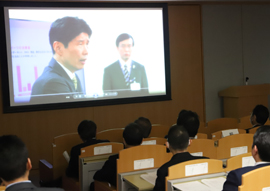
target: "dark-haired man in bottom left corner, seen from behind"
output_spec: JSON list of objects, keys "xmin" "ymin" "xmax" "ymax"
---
[{"xmin": 0, "ymin": 135, "xmax": 64, "ymax": 191}]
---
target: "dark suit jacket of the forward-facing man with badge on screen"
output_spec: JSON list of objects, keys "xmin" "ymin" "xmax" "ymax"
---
[{"xmin": 103, "ymin": 60, "xmax": 148, "ymax": 96}]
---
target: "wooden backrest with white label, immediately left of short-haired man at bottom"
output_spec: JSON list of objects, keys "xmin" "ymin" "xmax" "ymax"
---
[{"xmin": 117, "ymin": 145, "xmax": 172, "ymax": 174}]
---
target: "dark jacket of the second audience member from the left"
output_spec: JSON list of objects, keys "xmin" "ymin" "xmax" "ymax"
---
[{"xmin": 66, "ymin": 139, "xmax": 109, "ymax": 178}]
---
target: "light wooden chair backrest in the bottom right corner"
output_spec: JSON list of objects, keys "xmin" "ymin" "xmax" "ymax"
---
[{"xmin": 238, "ymin": 166, "xmax": 270, "ymax": 191}]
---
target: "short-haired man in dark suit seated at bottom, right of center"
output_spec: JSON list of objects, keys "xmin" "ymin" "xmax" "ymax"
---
[{"xmin": 154, "ymin": 125, "xmax": 207, "ymax": 191}]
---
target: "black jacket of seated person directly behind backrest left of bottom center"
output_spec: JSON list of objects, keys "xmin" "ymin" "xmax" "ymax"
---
[{"xmin": 94, "ymin": 154, "xmax": 119, "ymax": 186}]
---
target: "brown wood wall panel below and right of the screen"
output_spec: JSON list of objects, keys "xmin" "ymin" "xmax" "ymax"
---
[{"xmin": 0, "ymin": 5, "xmax": 205, "ymax": 168}]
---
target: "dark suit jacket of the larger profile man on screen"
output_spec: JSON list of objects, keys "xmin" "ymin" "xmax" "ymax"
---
[{"xmin": 31, "ymin": 58, "xmax": 83, "ymax": 101}]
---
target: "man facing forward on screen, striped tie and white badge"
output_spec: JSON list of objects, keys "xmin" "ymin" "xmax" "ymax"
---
[{"xmin": 103, "ymin": 33, "xmax": 148, "ymax": 96}]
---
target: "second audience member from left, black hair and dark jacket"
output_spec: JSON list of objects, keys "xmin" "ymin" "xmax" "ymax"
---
[{"xmin": 66, "ymin": 120, "xmax": 109, "ymax": 178}]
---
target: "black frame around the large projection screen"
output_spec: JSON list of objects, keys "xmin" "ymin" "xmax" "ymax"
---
[{"xmin": 0, "ymin": 1, "xmax": 171, "ymax": 113}]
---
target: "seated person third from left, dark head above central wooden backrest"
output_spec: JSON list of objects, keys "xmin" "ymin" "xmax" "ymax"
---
[{"xmin": 94, "ymin": 123, "xmax": 143, "ymax": 186}]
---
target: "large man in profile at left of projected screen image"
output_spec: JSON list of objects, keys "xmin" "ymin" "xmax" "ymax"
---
[{"xmin": 31, "ymin": 17, "xmax": 92, "ymax": 101}]
